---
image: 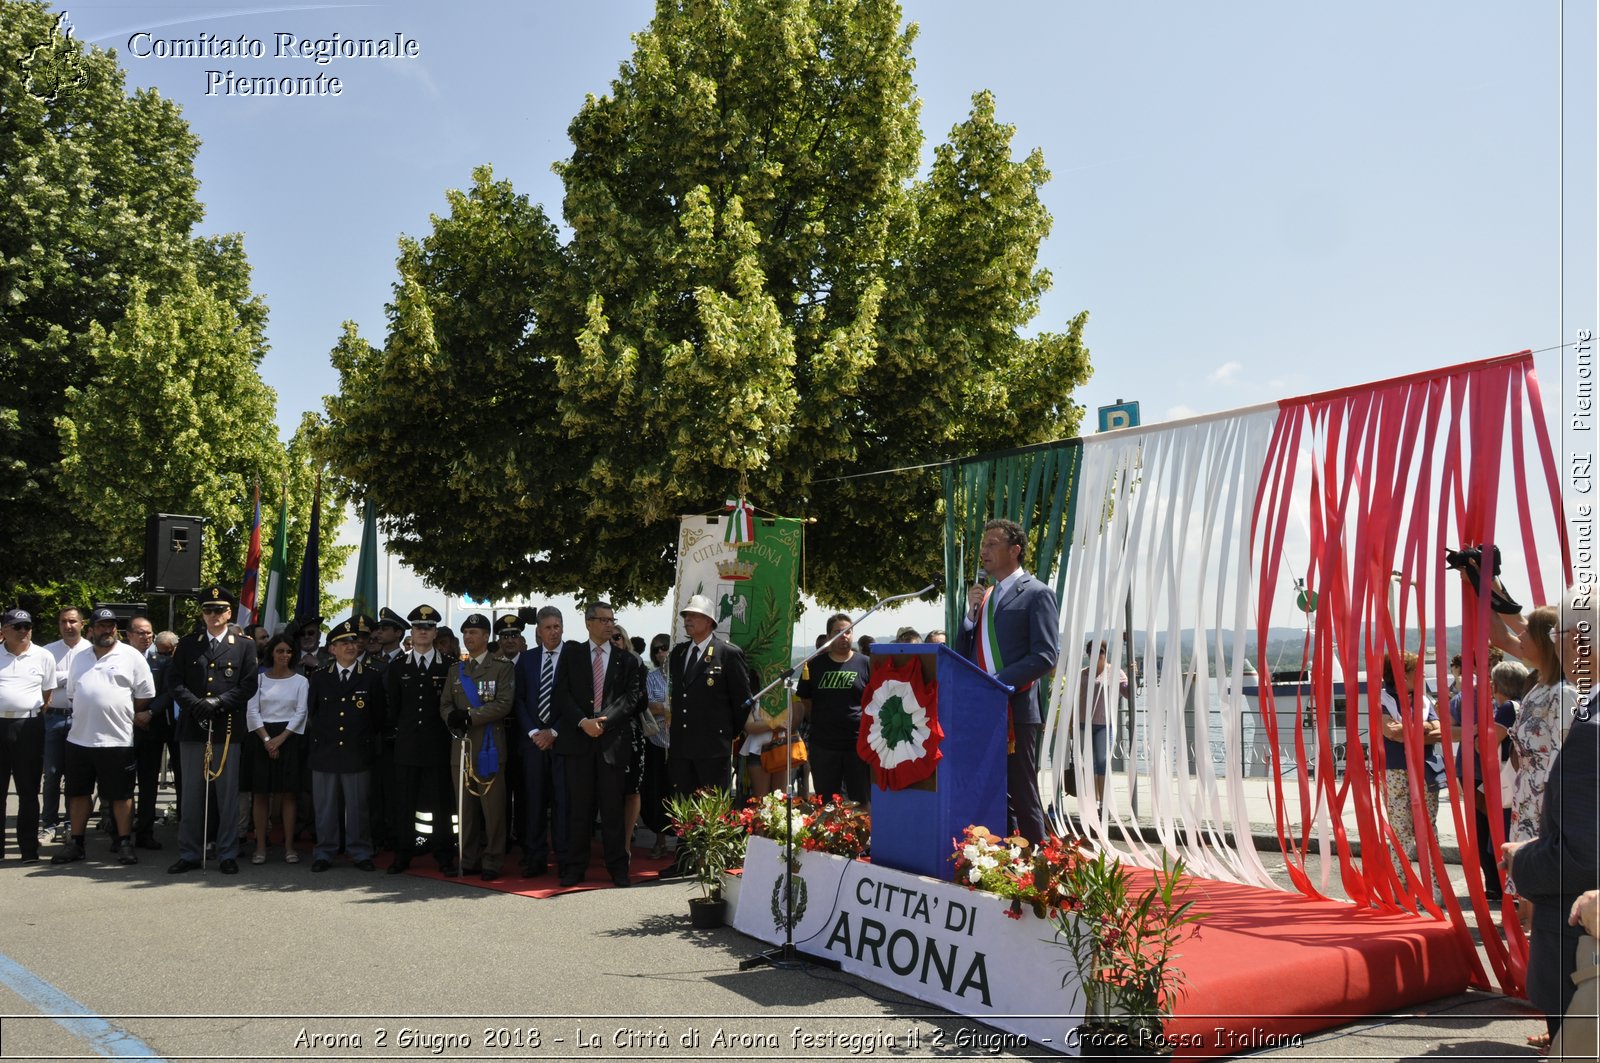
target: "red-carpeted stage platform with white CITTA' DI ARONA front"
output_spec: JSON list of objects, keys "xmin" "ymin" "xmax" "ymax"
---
[{"xmin": 733, "ymin": 839, "xmax": 1467, "ymax": 1060}]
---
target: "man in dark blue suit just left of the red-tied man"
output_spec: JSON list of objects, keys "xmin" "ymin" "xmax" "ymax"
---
[{"xmin": 515, "ymin": 605, "xmax": 571, "ymax": 879}]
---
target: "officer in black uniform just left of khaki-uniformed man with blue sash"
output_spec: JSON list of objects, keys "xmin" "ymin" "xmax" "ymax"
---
[{"xmin": 384, "ymin": 605, "xmax": 456, "ymax": 874}]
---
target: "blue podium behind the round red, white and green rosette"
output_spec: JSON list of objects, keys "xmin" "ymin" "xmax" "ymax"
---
[{"xmin": 872, "ymin": 642, "xmax": 1011, "ymax": 882}]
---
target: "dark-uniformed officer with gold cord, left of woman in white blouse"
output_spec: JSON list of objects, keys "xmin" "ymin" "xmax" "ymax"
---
[{"xmin": 166, "ymin": 586, "xmax": 256, "ymax": 874}]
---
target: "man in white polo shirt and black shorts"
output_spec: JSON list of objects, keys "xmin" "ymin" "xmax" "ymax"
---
[{"xmin": 50, "ymin": 608, "xmax": 155, "ymax": 864}]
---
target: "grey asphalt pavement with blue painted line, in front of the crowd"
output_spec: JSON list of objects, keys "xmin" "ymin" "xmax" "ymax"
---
[{"xmin": 0, "ymin": 794, "xmax": 1542, "ymax": 1061}]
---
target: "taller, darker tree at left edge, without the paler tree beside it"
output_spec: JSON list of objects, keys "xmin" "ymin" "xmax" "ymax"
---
[{"xmin": 0, "ymin": 0, "xmax": 202, "ymax": 594}]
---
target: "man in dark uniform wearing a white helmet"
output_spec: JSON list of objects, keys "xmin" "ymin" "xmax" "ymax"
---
[{"xmin": 667, "ymin": 594, "xmax": 750, "ymax": 794}]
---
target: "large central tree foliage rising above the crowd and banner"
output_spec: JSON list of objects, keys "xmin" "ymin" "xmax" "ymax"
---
[{"xmin": 325, "ymin": 0, "xmax": 1088, "ymax": 605}]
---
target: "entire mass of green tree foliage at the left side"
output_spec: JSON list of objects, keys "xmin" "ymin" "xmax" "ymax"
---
[{"xmin": 0, "ymin": 0, "xmax": 333, "ymax": 616}]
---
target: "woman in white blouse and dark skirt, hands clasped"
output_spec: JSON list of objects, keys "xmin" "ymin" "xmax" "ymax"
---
[{"xmin": 242, "ymin": 636, "xmax": 310, "ymax": 863}]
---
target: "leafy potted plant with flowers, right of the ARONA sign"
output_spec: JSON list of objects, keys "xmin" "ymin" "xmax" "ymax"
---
[{"xmin": 1054, "ymin": 850, "xmax": 1202, "ymax": 1058}]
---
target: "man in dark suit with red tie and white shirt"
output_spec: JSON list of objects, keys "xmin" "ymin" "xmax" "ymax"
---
[{"xmin": 555, "ymin": 602, "xmax": 645, "ymax": 887}]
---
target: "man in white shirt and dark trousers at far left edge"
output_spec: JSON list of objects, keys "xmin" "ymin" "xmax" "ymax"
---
[{"xmin": 0, "ymin": 608, "xmax": 56, "ymax": 863}]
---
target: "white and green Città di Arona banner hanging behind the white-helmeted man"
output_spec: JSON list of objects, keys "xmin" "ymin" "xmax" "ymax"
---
[{"xmin": 672, "ymin": 517, "xmax": 803, "ymax": 716}]
